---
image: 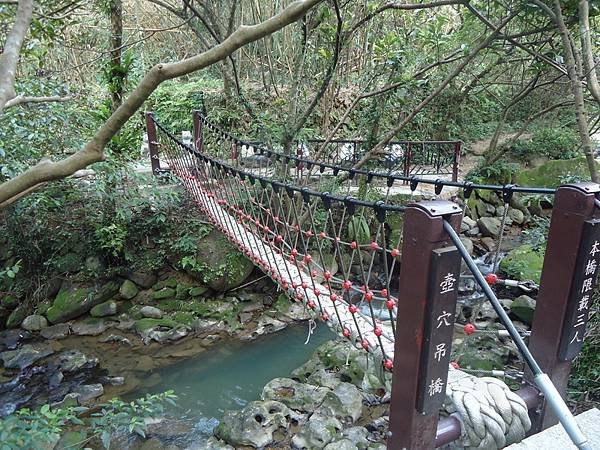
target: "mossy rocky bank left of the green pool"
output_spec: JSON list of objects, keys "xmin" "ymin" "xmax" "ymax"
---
[{"xmin": 0, "ymin": 272, "xmax": 314, "ymax": 416}]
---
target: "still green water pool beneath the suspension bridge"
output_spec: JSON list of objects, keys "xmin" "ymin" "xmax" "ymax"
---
[{"xmin": 135, "ymin": 323, "xmax": 335, "ymax": 438}]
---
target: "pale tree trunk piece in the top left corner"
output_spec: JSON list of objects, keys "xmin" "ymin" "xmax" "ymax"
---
[{"xmin": 0, "ymin": 0, "xmax": 33, "ymax": 114}]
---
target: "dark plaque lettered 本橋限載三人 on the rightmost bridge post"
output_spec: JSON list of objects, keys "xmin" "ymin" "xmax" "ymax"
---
[{"xmin": 558, "ymin": 219, "xmax": 600, "ymax": 361}]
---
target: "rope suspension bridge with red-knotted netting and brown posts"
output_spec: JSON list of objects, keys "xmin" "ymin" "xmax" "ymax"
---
[{"xmin": 146, "ymin": 111, "xmax": 600, "ymax": 450}]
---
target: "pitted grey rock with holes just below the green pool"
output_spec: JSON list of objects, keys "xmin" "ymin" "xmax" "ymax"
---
[{"xmin": 215, "ymin": 401, "xmax": 290, "ymax": 448}]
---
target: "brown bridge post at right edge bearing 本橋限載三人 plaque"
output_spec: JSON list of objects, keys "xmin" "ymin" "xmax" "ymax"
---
[{"xmin": 525, "ymin": 183, "xmax": 600, "ymax": 434}]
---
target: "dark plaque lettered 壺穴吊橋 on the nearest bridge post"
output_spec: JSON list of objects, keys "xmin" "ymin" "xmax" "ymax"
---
[{"xmin": 417, "ymin": 247, "xmax": 460, "ymax": 413}]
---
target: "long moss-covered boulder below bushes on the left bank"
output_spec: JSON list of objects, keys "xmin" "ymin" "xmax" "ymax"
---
[{"xmin": 46, "ymin": 281, "xmax": 119, "ymax": 324}]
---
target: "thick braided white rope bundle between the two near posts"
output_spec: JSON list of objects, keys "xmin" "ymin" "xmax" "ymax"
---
[{"xmin": 445, "ymin": 370, "xmax": 531, "ymax": 450}]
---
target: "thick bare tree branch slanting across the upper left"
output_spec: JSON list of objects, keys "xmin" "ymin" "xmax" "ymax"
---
[{"xmin": 0, "ymin": 0, "xmax": 322, "ymax": 204}]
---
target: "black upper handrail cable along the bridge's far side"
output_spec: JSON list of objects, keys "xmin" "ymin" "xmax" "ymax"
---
[{"xmin": 194, "ymin": 111, "xmax": 556, "ymax": 198}]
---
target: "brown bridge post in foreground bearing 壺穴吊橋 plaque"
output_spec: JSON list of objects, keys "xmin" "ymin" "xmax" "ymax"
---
[{"xmin": 387, "ymin": 200, "xmax": 462, "ymax": 450}]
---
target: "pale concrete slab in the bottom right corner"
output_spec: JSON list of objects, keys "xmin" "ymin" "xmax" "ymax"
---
[{"xmin": 506, "ymin": 408, "xmax": 600, "ymax": 450}]
